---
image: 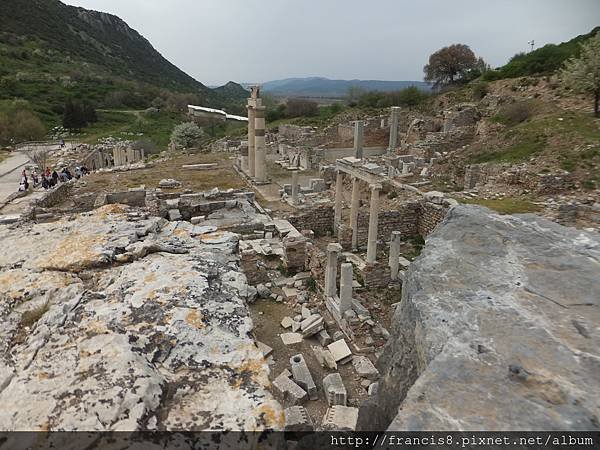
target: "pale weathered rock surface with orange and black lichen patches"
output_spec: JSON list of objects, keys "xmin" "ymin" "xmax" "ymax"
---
[{"xmin": 0, "ymin": 205, "xmax": 284, "ymax": 430}]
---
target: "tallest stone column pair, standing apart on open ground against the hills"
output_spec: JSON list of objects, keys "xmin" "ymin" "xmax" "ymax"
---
[{"xmin": 248, "ymin": 86, "xmax": 267, "ymax": 183}]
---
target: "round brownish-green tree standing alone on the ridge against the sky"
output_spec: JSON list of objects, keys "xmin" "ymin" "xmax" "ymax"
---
[{"xmin": 423, "ymin": 44, "xmax": 477, "ymax": 87}]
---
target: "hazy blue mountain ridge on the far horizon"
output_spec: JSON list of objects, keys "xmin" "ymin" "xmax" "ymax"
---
[{"xmin": 255, "ymin": 77, "xmax": 430, "ymax": 97}]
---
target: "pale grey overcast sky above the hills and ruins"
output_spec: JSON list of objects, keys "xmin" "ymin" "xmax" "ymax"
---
[{"xmin": 63, "ymin": 0, "xmax": 600, "ymax": 85}]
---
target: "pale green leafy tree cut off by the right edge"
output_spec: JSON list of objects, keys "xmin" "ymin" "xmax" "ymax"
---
[{"xmin": 560, "ymin": 33, "xmax": 600, "ymax": 117}]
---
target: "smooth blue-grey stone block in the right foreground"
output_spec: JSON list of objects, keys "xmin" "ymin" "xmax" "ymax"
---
[{"xmin": 358, "ymin": 206, "xmax": 600, "ymax": 430}]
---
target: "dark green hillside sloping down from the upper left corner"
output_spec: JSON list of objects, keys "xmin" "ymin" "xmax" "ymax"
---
[{"xmin": 0, "ymin": 0, "xmax": 245, "ymax": 119}]
